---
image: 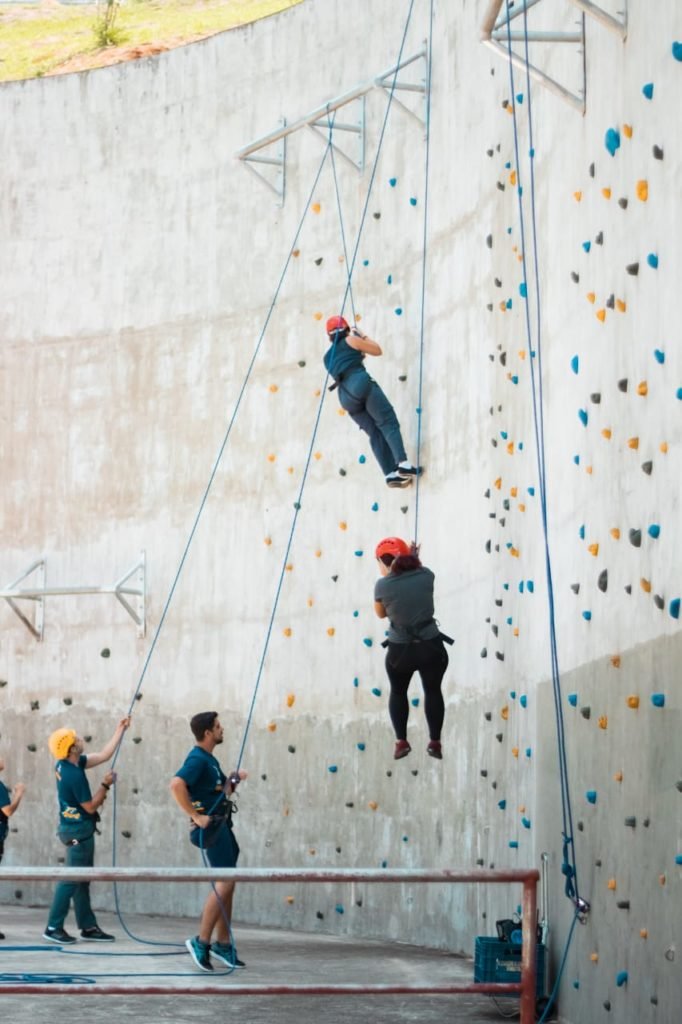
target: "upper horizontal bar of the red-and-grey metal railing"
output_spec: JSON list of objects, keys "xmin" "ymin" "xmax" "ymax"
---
[{"xmin": 0, "ymin": 866, "xmax": 540, "ymax": 884}]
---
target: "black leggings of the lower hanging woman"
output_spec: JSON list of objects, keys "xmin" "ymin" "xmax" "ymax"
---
[{"xmin": 386, "ymin": 637, "xmax": 449, "ymax": 740}]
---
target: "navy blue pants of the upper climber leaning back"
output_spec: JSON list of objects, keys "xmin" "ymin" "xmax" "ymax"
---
[{"xmin": 339, "ymin": 368, "xmax": 408, "ymax": 476}]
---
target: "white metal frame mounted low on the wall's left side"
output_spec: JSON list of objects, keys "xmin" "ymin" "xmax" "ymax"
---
[{"xmin": 0, "ymin": 551, "xmax": 146, "ymax": 640}]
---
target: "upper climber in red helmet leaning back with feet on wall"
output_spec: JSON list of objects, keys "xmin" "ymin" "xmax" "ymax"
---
[{"xmin": 325, "ymin": 316, "xmax": 421, "ymax": 487}]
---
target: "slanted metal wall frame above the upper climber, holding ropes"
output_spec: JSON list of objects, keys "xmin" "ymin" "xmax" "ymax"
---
[{"xmin": 235, "ymin": 43, "xmax": 429, "ymax": 206}]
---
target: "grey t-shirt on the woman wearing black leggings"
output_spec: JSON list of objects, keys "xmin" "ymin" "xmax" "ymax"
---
[{"xmin": 374, "ymin": 566, "xmax": 440, "ymax": 643}]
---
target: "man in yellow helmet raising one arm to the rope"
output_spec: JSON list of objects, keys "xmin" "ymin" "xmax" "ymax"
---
[{"xmin": 43, "ymin": 718, "xmax": 130, "ymax": 945}]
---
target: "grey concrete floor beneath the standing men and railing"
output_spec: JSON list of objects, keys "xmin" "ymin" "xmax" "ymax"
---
[{"xmin": 0, "ymin": 907, "xmax": 518, "ymax": 1024}]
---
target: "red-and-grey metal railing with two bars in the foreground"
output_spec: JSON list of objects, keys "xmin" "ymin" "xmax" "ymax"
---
[{"xmin": 0, "ymin": 867, "xmax": 540, "ymax": 1024}]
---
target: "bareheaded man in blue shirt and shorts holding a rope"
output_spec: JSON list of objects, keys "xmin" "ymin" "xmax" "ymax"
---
[{"xmin": 170, "ymin": 711, "xmax": 247, "ymax": 971}]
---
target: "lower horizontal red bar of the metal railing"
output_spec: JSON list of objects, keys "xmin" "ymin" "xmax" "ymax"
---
[{"xmin": 0, "ymin": 971, "xmax": 521, "ymax": 996}]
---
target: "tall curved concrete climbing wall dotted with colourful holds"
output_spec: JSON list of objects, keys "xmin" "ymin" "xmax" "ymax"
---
[{"xmin": 0, "ymin": 0, "xmax": 682, "ymax": 1022}]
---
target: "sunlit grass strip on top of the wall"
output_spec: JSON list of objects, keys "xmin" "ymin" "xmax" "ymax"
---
[{"xmin": 0, "ymin": 0, "xmax": 302, "ymax": 82}]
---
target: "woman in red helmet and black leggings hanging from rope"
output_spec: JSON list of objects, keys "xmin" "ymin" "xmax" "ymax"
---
[{"xmin": 374, "ymin": 537, "xmax": 454, "ymax": 761}]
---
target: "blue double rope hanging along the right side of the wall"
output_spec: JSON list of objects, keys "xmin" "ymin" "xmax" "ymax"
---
[{"xmin": 499, "ymin": 0, "xmax": 580, "ymax": 902}]
